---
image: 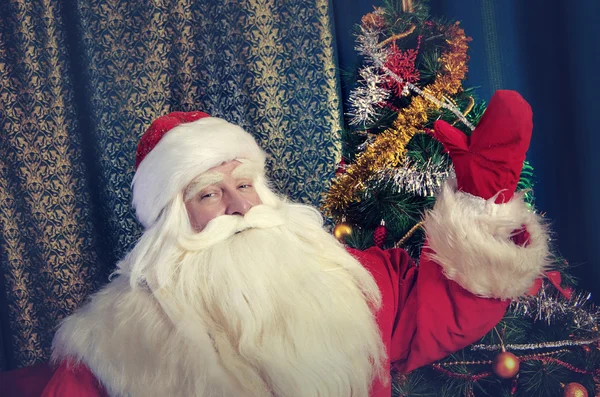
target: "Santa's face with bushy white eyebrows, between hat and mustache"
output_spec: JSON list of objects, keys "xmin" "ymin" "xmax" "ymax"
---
[{"xmin": 184, "ymin": 160, "xmax": 261, "ymax": 232}]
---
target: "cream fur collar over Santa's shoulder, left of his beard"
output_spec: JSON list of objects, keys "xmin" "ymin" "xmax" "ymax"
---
[{"xmin": 52, "ymin": 276, "xmax": 244, "ymax": 397}]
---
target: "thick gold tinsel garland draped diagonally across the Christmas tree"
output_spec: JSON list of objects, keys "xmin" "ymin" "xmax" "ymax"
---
[{"xmin": 323, "ymin": 22, "xmax": 471, "ymax": 216}]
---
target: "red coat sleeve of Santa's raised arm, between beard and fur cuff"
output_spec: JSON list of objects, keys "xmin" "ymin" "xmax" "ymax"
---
[{"xmin": 350, "ymin": 247, "xmax": 509, "ymax": 373}]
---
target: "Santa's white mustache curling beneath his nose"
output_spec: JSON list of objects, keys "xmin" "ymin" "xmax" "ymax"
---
[{"xmin": 178, "ymin": 204, "xmax": 286, "ymax": 251}]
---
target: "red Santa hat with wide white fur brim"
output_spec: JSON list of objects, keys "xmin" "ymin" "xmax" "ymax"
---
[{"xmin": 132, "ymin": 112, "xmax": 265, "ymax": 228}]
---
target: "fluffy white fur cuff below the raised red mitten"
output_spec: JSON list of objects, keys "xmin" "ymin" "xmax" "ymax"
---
[{"xmin": 424, "ymin": 180, "xmax": 549, "ymax": 299}]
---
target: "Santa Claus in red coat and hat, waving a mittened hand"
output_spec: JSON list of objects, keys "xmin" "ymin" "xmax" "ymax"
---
[{"xmin": 43, "ymin": 91, "xmax": 547, "ymax": 397}]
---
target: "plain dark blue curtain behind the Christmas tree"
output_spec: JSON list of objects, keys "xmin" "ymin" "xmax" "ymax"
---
[{"xmin": 332, "ymin": 0, "xmax": 600, "ymax": 303}]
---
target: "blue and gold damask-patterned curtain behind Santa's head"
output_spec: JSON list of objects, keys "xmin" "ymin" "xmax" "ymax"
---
[{"xmin": 0, "ymin": 0, "xmax": 341, "ymax": 369}]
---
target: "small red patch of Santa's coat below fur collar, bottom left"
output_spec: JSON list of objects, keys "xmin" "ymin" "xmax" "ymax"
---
[{"xmin": 41, "ymin": 361, "xmax": 108, "ymax": 397}]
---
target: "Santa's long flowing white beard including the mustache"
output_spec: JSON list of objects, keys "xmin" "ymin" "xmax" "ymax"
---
[{"xmin": 54, "ymin": 199, "xmax": 388, "ymax": 397}]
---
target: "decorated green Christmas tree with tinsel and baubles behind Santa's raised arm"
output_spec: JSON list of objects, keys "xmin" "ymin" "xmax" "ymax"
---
[{"xmin": 323, "ymin": 0, "xmax": 600, "ymax": 397}]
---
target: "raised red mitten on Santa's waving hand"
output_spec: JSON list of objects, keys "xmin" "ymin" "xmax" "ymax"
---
[{"xmin": 434, "ymin": 90, "xmax": 533, "ymax": 204}]
